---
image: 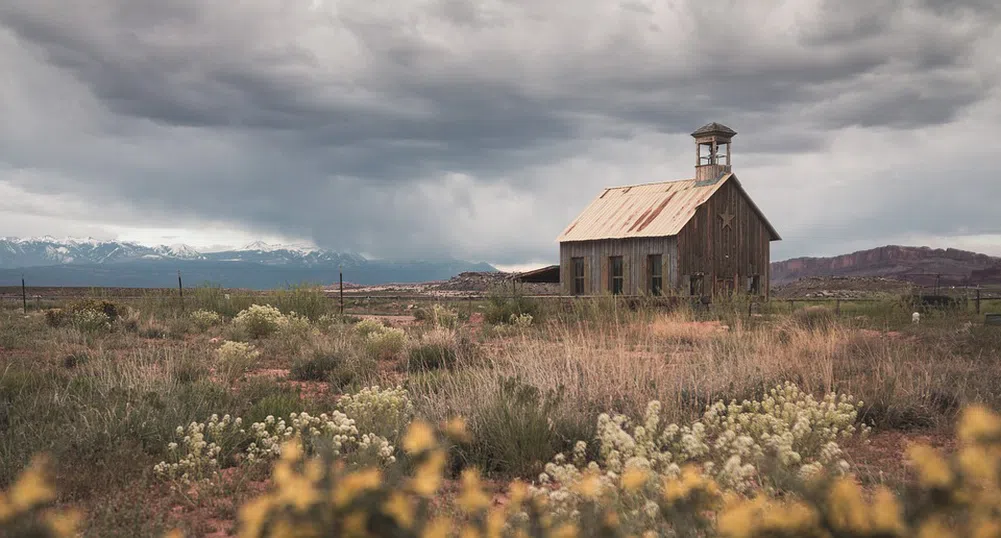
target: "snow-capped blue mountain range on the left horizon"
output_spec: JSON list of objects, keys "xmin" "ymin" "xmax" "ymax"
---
[{"xmin": 0, "ymin": 236, "xmax": 496, "ymax": 290}]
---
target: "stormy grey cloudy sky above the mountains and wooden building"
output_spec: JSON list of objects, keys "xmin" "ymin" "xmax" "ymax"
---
[{"xmin": 0, "ymin": 0, "xmax": 1001, "ymax": 266}]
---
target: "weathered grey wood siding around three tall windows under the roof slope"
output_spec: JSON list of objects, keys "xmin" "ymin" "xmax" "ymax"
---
[{"xmin": 560, "ymin": 237, "xmax": 678, "ymax": 295}]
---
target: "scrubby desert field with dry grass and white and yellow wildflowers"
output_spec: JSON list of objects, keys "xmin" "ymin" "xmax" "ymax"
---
[{"xmin": 0, "ymin": 288, "xmax": 1001, "ymax": 537}]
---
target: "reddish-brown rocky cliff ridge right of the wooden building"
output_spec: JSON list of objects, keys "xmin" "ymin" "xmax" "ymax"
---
[{"xmin": 772, "ymin": 244, "xmax": 1001, "ymax": 286}]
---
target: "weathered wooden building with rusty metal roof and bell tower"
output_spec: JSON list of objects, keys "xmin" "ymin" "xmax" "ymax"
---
[{"xmin": 557, "ymin": 122, "xmax": 781, "ymax": 299}]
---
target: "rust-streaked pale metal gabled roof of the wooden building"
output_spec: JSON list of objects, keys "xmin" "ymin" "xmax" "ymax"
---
[{"xmin": 557, "ymin": 172, "xmax": 781, "ymax": 242}]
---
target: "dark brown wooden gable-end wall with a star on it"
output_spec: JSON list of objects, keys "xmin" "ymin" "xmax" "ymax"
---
[{"xmin": 678, "ymin": 177, "xmax": 771, "ymax": 297}]
